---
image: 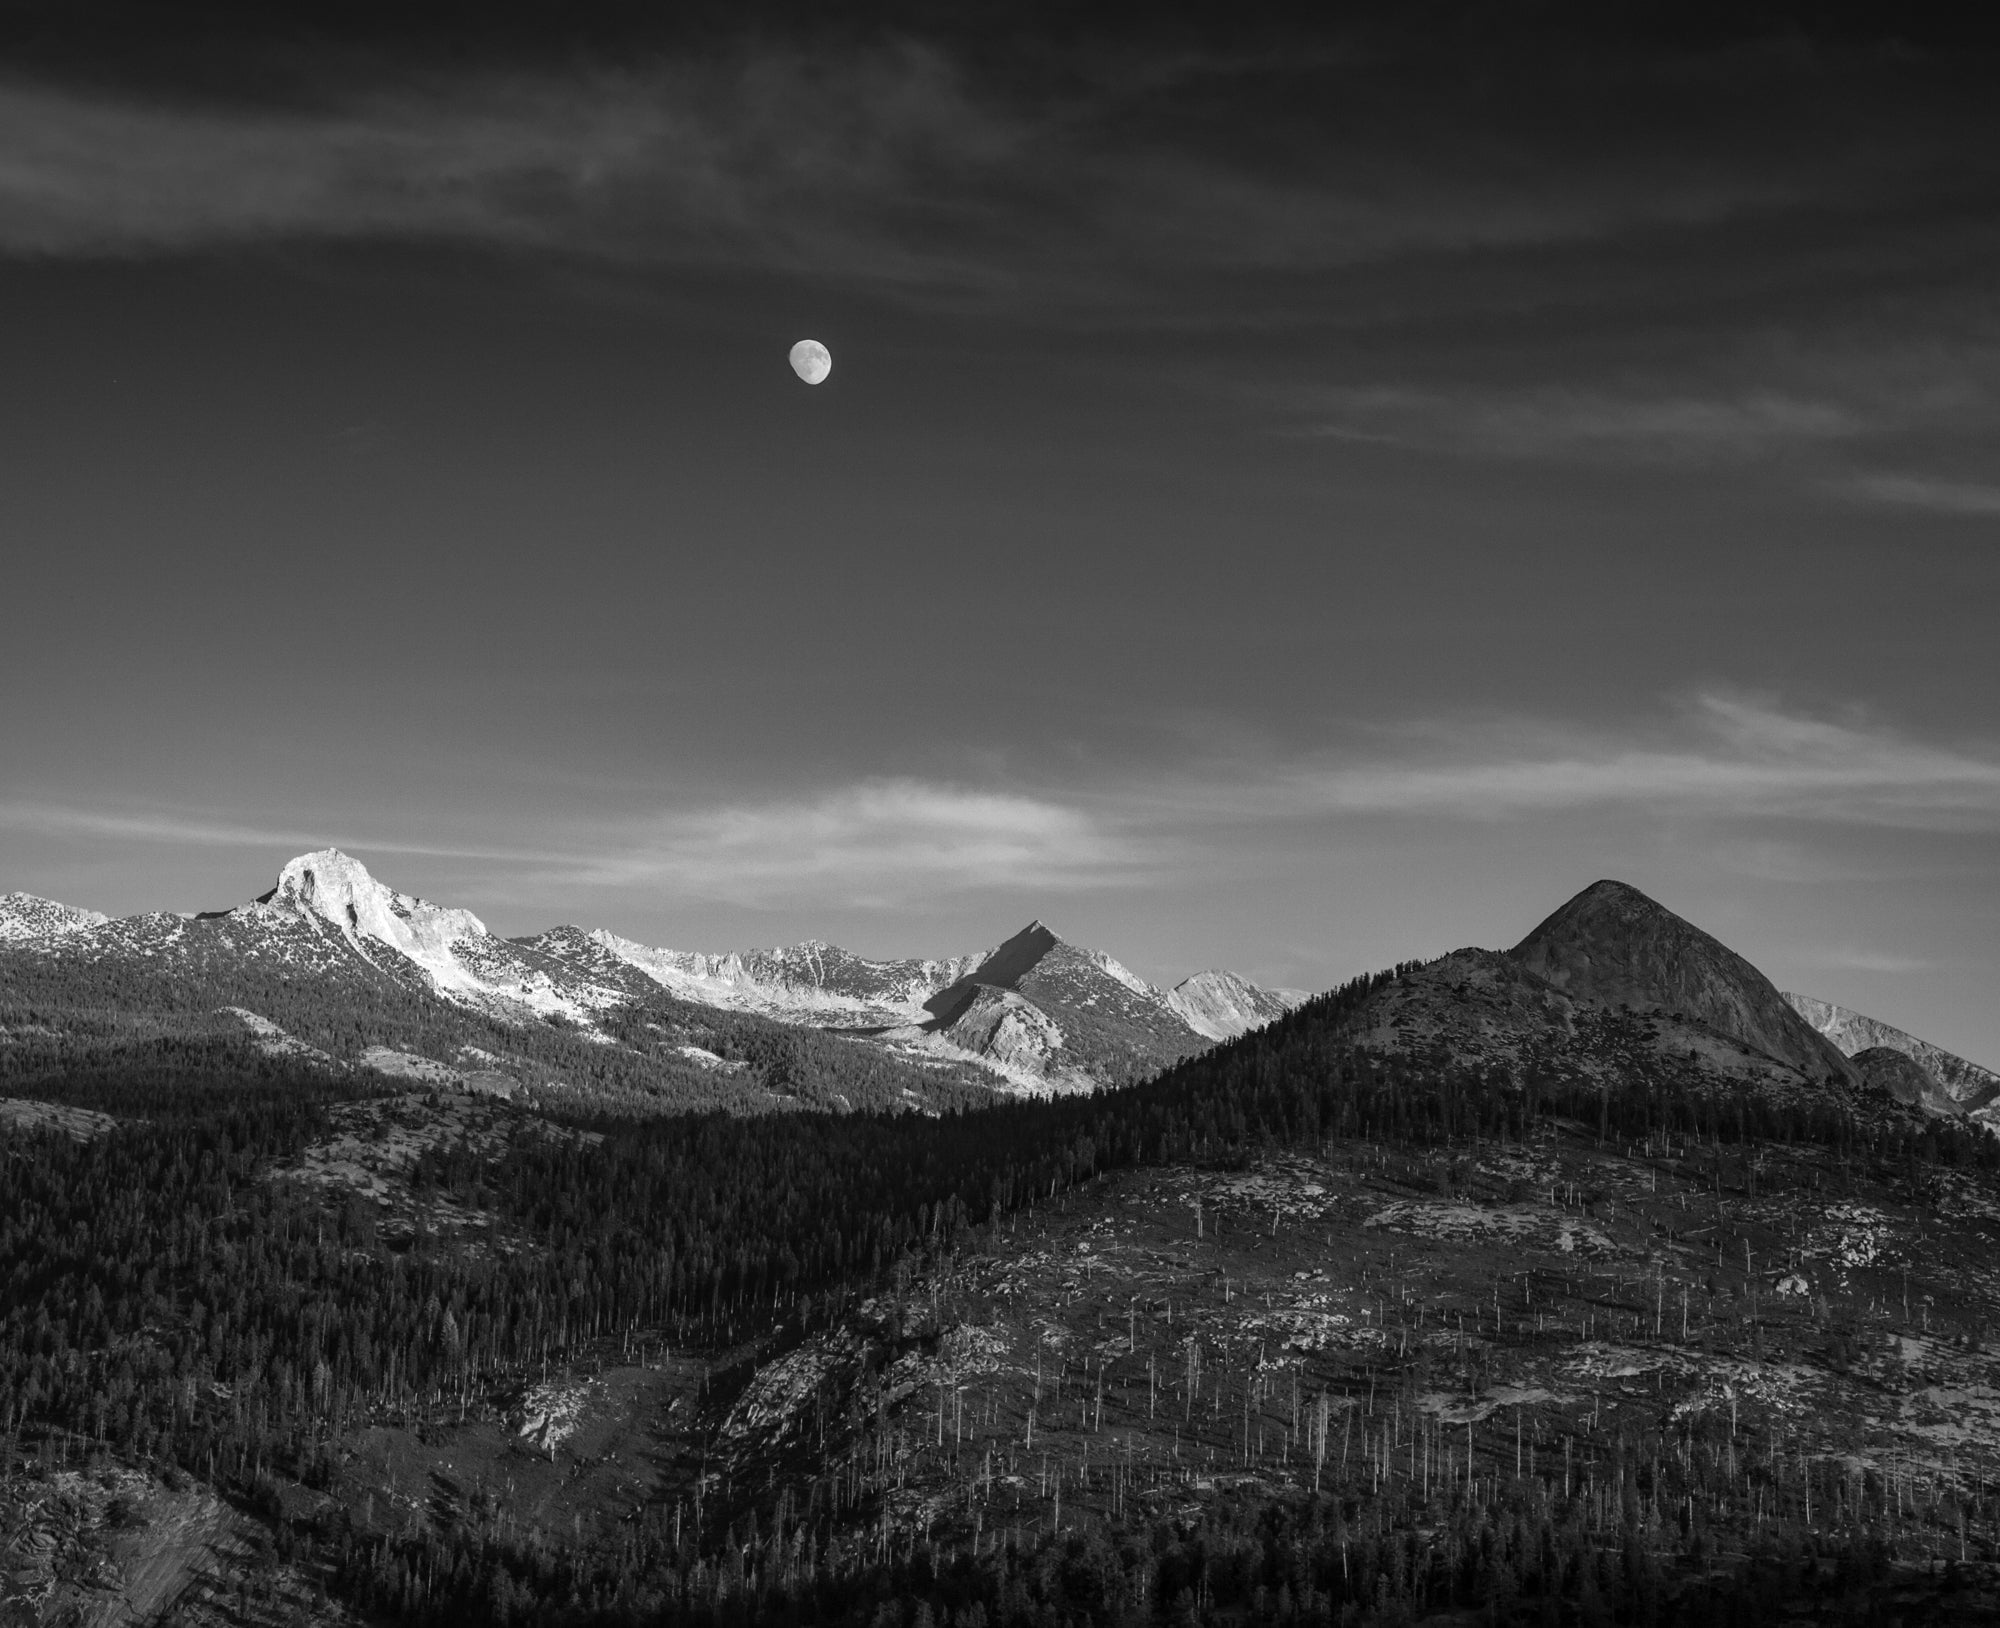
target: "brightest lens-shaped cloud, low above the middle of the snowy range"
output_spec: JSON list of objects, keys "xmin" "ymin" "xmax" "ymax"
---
[{"xmin": 556, "ymin": 780, "xmax": 1146, "ymax": 906}]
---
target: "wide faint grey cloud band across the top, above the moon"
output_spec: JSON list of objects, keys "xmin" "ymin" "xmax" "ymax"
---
[{"xmin": 0, "ymin": 40, "xmax": 1968, "ymax": 306}]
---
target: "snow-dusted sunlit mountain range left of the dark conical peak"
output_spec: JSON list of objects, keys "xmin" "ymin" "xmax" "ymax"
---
[{"xmin": 0, "ymin": 848, "xmax": 1304, "ymax": 1100}]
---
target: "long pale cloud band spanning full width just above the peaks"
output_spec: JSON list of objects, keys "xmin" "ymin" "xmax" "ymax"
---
[{"xmin": 0, "ymin": 694, "xmax": 2000, "ymax": 910}]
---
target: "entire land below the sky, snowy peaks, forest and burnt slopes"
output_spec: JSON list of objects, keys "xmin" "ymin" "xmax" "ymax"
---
[{"xmin": 0, "ymin": 850, "xmax": 2000, "ymax": 1628}]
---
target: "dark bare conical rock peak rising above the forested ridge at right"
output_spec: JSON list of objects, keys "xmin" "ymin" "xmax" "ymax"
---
[{"xmin": 1508, "ymin": 880, "xmax": 1856, "ymax": 1082}]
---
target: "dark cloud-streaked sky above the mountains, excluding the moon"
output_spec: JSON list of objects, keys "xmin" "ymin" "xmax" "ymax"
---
[{"xmin": 11, "ymin": 4, "xmax": 2000, "ymax": 1066}]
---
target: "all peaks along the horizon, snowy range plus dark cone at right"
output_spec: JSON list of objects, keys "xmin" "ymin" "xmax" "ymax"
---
[{"xmin": 0, "ymin": 868, "xmax": 2000, "ymax": 1124}]
